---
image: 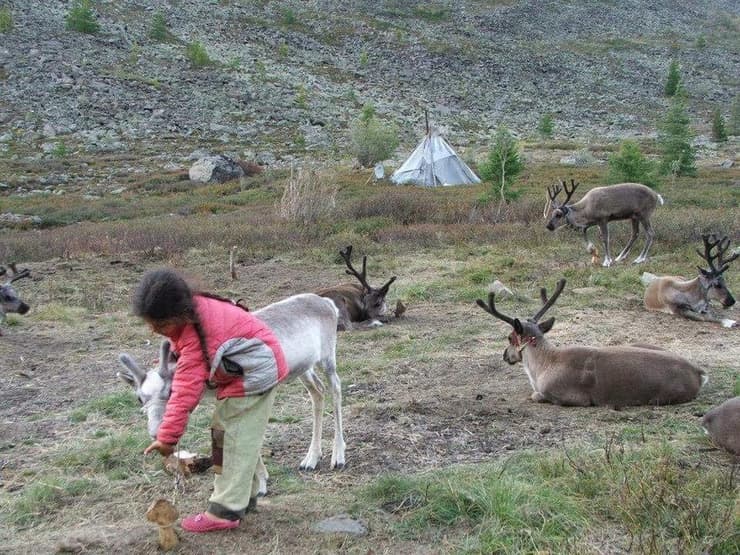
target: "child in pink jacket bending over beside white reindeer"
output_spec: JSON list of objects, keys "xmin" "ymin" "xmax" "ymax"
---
[{"xmin": 133, "ymin": 269, "xmax": 288, "ymax": 532}]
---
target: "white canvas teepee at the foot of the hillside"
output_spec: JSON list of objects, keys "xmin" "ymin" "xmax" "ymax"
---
[{"xmin": 391, "ymin": 116, "xmax": 480, "ymax": 187}]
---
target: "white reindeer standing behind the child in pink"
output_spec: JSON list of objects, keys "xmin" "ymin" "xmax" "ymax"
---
[{"xmin": 117, "ymin": 293, "xmax": 345, "ymax": 494}]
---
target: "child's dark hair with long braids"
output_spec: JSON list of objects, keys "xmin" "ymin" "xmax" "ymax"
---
[{"xmin": 132, "ymin": 268, "xmax": 246, "ymax": 367}]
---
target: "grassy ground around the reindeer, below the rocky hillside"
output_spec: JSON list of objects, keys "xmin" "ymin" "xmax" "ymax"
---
[{"xmin": 0, "ymin": 146, "xmax": 740, "ymax": 553}]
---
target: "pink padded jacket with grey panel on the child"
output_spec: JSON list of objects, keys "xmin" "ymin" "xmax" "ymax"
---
[{"xmin": 157, "ymin": 295, "xmax": 288, "ymax": 444}]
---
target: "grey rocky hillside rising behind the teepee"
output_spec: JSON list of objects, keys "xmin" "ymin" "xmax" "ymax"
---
[{"xmin": 0, "ymin": 0, "xmax": 740, "ymax": 172}]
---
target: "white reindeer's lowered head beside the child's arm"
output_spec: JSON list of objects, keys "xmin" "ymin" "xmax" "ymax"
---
[{"xmin": 116, "ymin": 340, "xmax": 176, "ymax": 438}]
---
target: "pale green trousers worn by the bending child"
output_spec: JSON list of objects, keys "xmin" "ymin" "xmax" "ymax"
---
[{"xmin": 208, "ymin": 387, "xmax": 275, "ymax": 520}]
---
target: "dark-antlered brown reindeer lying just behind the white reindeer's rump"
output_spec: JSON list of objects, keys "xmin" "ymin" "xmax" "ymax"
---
[{"xmin": 316, "ymin": 245, "xmax": 396, "ymax": 330}]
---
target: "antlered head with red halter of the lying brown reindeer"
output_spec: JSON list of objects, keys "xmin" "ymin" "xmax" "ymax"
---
[{"xmin": 476, "ymin": 279, "xmax": 565, "ymax": 364}]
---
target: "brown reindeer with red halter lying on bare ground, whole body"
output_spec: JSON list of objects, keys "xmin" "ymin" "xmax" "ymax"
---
[{"xmin": 477, "ymin": 279, "xmax": 706, "ymax": 407}]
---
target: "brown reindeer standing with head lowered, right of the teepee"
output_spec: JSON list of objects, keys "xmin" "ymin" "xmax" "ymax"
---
[{"xmin": 545, "ymin": 179, "xmax": 663, "ymax": 266}]
